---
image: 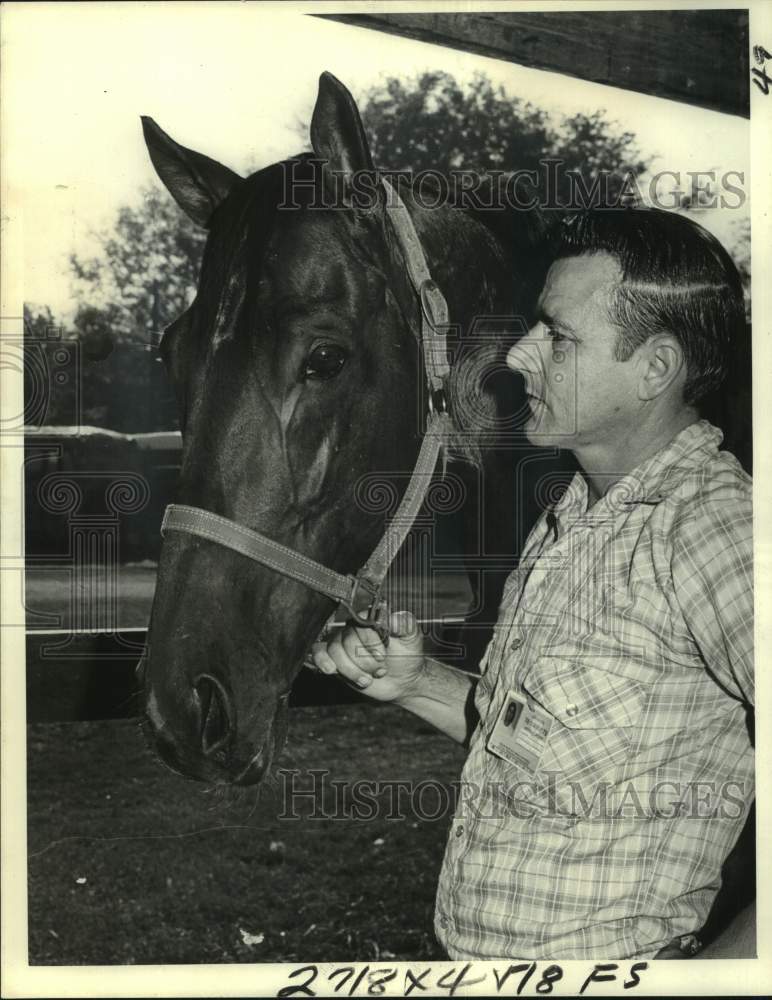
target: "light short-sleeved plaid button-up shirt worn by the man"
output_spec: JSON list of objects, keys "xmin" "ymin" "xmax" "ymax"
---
[{"xmin": 435, "ymin": 421, "xmax": 753, "ymax": 959}]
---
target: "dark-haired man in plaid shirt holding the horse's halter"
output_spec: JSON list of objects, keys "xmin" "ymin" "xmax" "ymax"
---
[{"xmin": 315, "ymin": 209, "xmax": 753, "ymax": 959}]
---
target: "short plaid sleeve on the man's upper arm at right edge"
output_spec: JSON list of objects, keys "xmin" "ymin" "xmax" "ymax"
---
[{"xmin": 672, "ymin": 481, "xmax": 755, "ymax": 705}]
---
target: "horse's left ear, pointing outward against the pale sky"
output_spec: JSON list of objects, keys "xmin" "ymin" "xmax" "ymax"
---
[{"xmin": 142, "ymin": 115, "xmax": 242, "ymax": 229}]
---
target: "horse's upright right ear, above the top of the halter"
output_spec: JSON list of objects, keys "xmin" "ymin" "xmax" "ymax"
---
[{"xmin": 311, "ymin": 72, "xmax": 373, "ymax": 174}]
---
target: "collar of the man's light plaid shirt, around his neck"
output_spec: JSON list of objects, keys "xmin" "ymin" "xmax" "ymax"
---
[{"xmin": 552, "ymin": 420, "xmax": 724, "ymax": 514}]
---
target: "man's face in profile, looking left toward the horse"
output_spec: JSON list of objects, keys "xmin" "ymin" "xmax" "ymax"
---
[{"xmin": 507, "ymin": 253, "xmax": 641, "ymax": 450}]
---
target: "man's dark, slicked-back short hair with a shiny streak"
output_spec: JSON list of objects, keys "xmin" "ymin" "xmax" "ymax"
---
[{"xmin": 555, "ymin": 208, "xmax": 745, "ymax": 404}]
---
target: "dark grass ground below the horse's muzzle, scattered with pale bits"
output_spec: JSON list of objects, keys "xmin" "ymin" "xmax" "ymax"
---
[{"xmin": 28, "ymin": 704, "xmax": 463, "ymax": 965}]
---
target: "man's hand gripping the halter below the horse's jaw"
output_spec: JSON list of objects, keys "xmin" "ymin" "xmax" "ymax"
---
[{"xmin": 311, "ymin": 611, "xmax": 425, "ymax": 702}]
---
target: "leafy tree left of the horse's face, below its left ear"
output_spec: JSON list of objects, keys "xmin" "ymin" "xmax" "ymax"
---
[{"xmin": 30, "ymin": 187, "xmax": 206, "ymax": 432}]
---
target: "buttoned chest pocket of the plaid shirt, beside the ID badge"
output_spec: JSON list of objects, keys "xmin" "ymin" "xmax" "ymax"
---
[{"xmin": 522, "ymin": 656, "xmax": 648, "ymax": 815}]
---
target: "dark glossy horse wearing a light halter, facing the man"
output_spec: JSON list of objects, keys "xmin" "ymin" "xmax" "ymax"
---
[{"xmin": 140, "ymin": 73, "xmax": 560, "ymax": 785}]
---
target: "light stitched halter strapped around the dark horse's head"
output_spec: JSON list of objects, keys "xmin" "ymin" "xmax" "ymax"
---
[{"xmin": 161, "ymin": 178, "xmax": 451, "ymax": 642}]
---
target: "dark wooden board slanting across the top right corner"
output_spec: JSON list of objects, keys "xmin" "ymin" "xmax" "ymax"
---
[{"xmin": 313, "ymin": 10, "xmax": 750, "ymax": 118}]
